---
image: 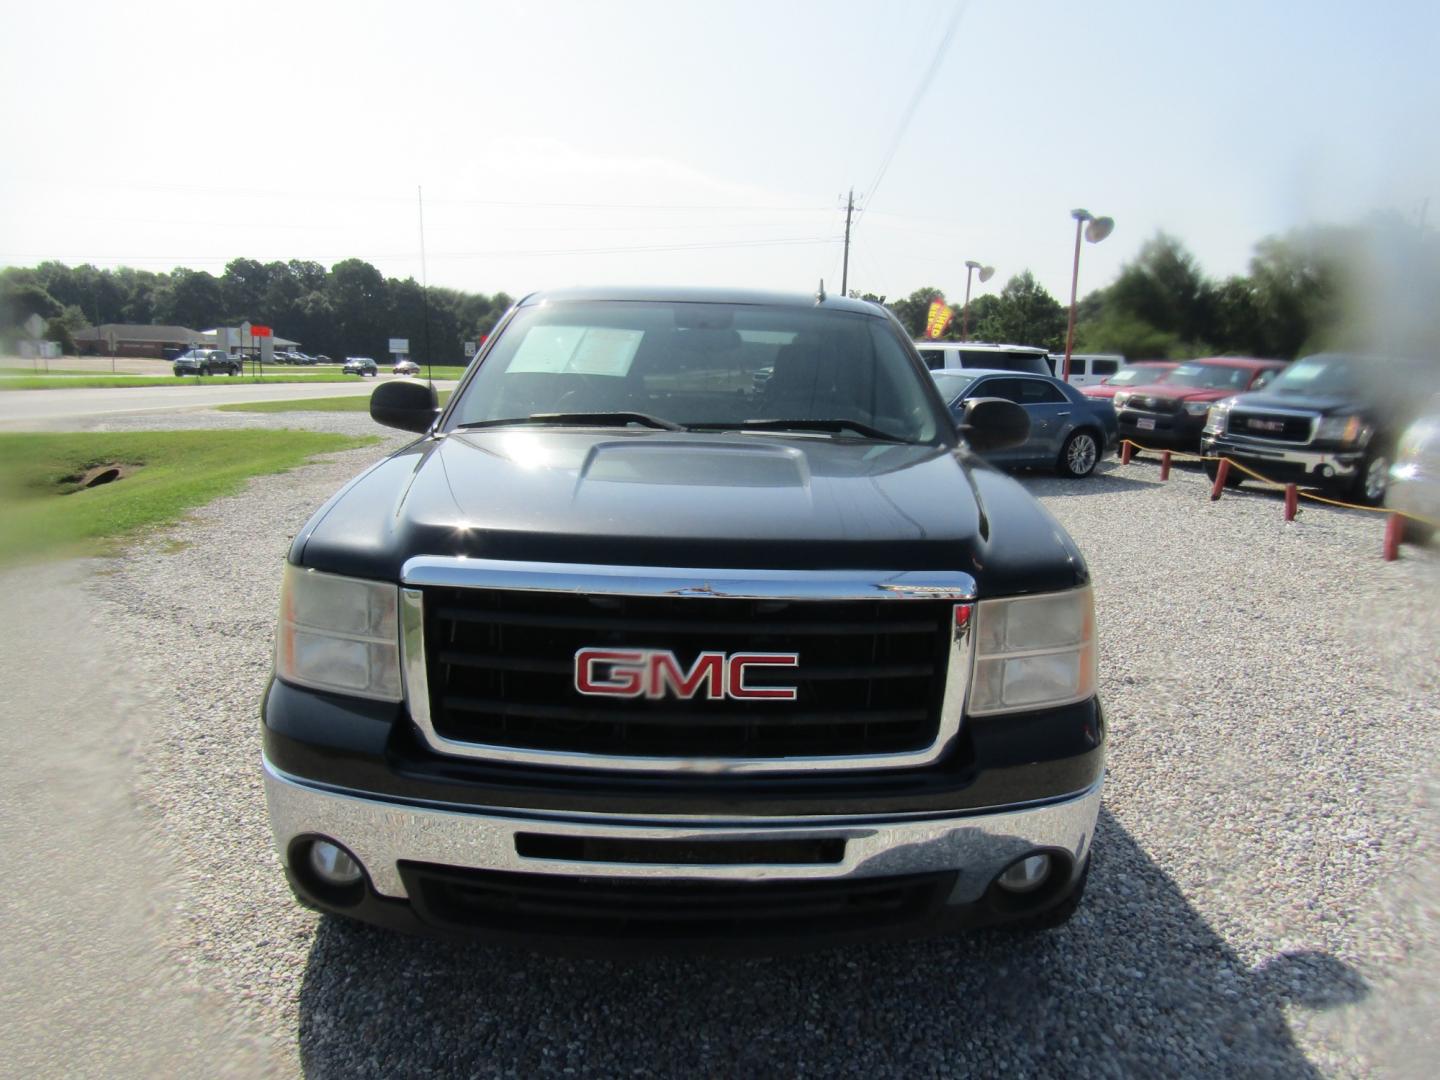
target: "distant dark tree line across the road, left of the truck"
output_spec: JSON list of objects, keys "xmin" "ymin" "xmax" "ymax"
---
[{"xmin": 0, "ymin": 258, "xmax": 511, "ymax": 363}]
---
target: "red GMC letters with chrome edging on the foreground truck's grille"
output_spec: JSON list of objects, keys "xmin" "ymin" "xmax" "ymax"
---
[{"xmin": 575, "ymin": 648, "xmax": 801, "ymax": 701}]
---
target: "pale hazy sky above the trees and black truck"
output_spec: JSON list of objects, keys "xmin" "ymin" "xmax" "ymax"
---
[{"xmin": 0, "ymin": 0, "xmax": 1440, "ymax": 300}]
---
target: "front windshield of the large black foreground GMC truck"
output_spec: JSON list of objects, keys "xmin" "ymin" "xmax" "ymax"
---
[{"xmin": 451, "ymin": 301, "xmax": 942, "ymax": 442}]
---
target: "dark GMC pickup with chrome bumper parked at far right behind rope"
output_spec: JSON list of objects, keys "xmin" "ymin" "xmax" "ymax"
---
[{"xmin": 1204, "ymin": 353, "xmax": 1440, "ymax": 504}]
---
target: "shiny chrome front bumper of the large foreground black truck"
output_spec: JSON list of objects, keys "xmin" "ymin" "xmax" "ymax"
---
[{"xmin": 264, "ymin": 760, "xmax": 1100, "ymax": 904}]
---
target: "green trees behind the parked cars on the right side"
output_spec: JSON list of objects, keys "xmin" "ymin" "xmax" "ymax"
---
[{"xmin": 852, "ymin": 216, "xmax": 1440, "ymax": 360}]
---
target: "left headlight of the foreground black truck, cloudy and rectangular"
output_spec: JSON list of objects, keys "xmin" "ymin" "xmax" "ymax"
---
[{"xmin": 275, "ymin": 564, "xmax": 400, "ymax": 701}]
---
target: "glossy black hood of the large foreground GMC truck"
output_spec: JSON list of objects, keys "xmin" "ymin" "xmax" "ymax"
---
[{"xmin": 300, "ymin": 429, "xmax": 1087, "ymax": 595}]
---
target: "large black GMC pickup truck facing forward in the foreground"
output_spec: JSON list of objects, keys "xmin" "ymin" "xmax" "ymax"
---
[{"xmin": 262, "ymin": 289, "xmax": 1104, "ymax": 950}]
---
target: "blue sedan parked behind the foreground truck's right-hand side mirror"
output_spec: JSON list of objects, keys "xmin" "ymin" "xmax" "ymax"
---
[{"xmin": 930, "ymin": 372, "xmax": 1119, "ymax": 477}]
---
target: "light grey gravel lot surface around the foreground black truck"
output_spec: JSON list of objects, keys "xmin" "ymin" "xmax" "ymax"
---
[{"xmin": 0, "ymin": 413, "xmax": 1440, "ymax": 1077}]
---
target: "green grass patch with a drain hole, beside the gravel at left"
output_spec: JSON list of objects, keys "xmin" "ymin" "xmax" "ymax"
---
[{"xmin": 0, "ymin": 431, "xmax": 376, "ymax": 563}]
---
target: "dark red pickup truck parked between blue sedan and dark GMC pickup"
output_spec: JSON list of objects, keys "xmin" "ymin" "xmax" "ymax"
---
[{"xmin": 1112, "ymin": 356, "xmax": 1284, "ymax": 449}]
